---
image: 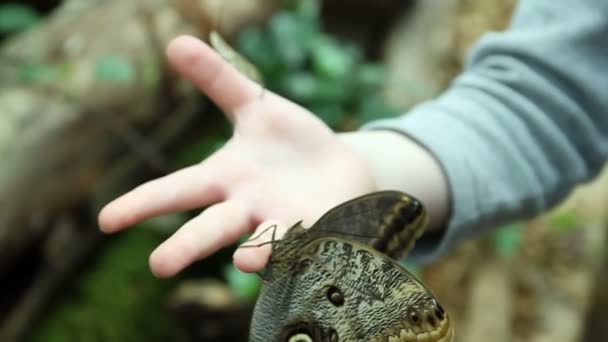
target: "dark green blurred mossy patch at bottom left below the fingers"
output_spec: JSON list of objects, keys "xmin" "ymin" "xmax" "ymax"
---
[{"xmin": 28, "ymin": 228, "xmax": 177, "ymax": 342}]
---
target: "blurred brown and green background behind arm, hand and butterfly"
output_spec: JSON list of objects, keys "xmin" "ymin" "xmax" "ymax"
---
[{"xmin": 0, "ymin": 0, "xmax": 608, "ymax": 342}]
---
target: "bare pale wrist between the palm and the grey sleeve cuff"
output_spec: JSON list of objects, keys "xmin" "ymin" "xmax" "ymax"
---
[{"xmin": 339, "ymin": 130, "xmax": 450, "ymax": 231}]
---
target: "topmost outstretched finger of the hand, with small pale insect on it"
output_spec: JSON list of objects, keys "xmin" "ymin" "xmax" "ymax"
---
[{"xmin": 167, "ymin": 36, "xmax": 260, "ymax": 121}]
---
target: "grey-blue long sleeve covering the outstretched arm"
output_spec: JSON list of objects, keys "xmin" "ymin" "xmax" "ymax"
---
[{"xmin": 364, "ymin": 0, "xmax": 608, "ymax": 262}]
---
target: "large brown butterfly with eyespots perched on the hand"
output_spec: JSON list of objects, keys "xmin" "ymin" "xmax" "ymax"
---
[{"xmin": 249, "ymin": 191, "xmax": 454, "ymax": 342}]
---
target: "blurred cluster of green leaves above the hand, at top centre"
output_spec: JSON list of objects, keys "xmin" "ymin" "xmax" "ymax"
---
[{"xmin": 237, "ymin": 0, "xmax": 399, "ymax": 129}]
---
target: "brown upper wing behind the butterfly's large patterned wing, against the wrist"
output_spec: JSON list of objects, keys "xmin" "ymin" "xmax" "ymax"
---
[{"xmin": 310, "ymin": 191, "xmax": 427, "ymax": 259}]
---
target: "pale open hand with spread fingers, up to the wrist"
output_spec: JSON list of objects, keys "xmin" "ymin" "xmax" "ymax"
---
[{"xmin": 100, "ymin": 37, "xmax": 373, "ymax": 276}]
